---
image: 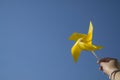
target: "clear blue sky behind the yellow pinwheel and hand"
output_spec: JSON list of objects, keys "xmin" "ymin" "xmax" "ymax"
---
[{"xmin": 0, "ymin": 0, "xmax": 120, "ymax": 80}]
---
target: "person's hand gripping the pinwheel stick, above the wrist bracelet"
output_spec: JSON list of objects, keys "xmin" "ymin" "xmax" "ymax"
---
[{"xmin": 98, "ymin": 58, "xmax": 120, "ymax": 76}]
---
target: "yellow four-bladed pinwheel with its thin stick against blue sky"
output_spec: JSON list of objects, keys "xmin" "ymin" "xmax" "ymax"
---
[{"xmin": 69, "ymin": 21, "xmax": 102, "ymax": 62}]
